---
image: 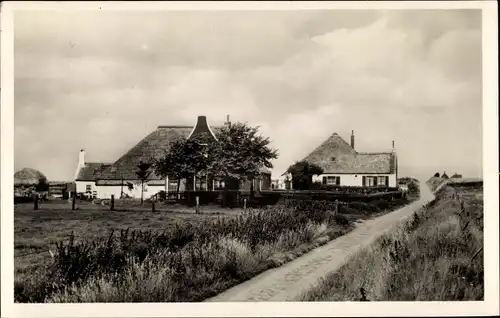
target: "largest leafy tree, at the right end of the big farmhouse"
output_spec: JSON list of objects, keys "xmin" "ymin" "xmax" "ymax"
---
[{"xmin": 207, "ymin": 123, "xmax": 278, "ymax": 203}]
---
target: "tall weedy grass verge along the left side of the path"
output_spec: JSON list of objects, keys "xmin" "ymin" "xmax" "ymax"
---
[{"xmin": 14, "ymin": 195, "xmax": 414, "ymax": 302}]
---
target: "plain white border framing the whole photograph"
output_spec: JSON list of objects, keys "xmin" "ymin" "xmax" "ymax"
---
[{"xmin": 0, "ymin": 1, "xmax": 499, "ymax": 317}]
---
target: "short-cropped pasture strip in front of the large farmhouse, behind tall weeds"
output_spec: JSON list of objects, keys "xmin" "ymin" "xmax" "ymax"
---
[{"xmin": 14, "ymin": 200, "xmax": 243, "ymax": 275}]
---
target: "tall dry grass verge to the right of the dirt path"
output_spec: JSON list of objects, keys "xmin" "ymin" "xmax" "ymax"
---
[{"xmin": 301, "ymin": 181, "xmax": 484, "ymax": 301}]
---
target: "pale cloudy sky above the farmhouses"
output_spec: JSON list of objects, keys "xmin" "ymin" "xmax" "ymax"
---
[{"xmin": 14, "ymin": 10, "xmax": 482, "ymax": 181}]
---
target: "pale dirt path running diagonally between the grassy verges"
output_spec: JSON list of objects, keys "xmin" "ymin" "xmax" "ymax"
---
[{"xmin": 206, "ymin": 181, "xmax": 434, "ymax": 302}]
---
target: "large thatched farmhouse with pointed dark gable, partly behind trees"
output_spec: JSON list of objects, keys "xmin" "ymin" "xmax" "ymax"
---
[{"xmin": 75, "ymin": 116, "xmax": 271, "ymax": 198}]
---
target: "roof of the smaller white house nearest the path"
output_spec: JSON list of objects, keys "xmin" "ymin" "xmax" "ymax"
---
[{"xmin": 298, "ymin": 133, "xmax": 397, "ymax": 174}]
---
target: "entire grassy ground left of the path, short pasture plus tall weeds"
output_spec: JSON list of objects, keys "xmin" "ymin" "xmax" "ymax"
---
[{"xmin": 14, "ymin": 188, "xmax": 411, "ymax": 302}]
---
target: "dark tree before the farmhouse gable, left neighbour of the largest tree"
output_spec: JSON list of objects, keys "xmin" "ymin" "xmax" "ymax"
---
[{"xmin": 153, "ymin": 138, "xmax": 209, "ymax": 197}]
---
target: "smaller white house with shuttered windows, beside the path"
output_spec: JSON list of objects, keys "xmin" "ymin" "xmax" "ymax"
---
[{"xmin": 298, "ymin": 131, "xmax": 398, "ymax": 187}]
